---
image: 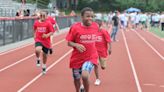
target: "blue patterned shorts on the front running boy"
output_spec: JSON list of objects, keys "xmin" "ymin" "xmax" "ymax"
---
[{"xmin": 72, "ymin": 61, "xmax": 94, "ymax": 79}]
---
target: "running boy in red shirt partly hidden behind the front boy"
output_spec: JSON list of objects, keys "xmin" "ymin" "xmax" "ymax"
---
[{"xmin": 94, "ymin": 20, "xmax": 111, "ymax": 85}]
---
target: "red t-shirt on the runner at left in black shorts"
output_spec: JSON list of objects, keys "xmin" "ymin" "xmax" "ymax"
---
[{"xmin": 33, "ymin": 20, "xmax": 54, "ymax": 48}]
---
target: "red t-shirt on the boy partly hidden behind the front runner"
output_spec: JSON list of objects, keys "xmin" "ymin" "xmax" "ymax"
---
[{"xmin": 96, "ymin": 29, "xmax": 111, "ymax": 58}]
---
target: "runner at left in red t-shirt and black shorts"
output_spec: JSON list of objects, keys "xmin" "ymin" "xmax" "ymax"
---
[{"xmin": 33, "ymin": 11, "xmax": 54, "ymax": 74}]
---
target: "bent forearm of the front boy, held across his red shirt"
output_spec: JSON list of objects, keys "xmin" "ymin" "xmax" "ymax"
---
[{"xmin": 68, "ymin": 41, "xmax": 86, "ymax": 53}]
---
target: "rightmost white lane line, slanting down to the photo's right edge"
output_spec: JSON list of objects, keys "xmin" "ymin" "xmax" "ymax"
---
[{"xmin": 133, "ymin": 31, "xmax": 164, "ymax": 60}]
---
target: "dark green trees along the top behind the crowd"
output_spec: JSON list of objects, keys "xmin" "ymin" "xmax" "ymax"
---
[{"xmin": 17, "ymin": 0, "xmax": 164, "ymax": 12}]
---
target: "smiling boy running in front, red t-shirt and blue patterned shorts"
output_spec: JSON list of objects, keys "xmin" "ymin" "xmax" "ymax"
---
[{"xmin": 66, "ymin": 7, "xmax": 98, "ymax": 92}]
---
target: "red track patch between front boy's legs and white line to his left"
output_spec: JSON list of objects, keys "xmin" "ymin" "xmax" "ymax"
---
[{"xmin": 18, "ymin": 51, "xmax": 74, "ymax": 92}]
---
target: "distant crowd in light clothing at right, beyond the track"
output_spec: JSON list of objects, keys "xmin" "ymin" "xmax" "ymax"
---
[{"xmin": 108, "ymin": 11, "xmax": 164, "ymax": 31}]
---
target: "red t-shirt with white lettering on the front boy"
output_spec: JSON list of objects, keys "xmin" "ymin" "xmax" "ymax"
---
[{"xmin": 66, "ymin": 22, "xmax": 98, "ymax": 68}]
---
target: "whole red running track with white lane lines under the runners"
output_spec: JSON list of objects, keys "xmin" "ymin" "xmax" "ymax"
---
[{"xmin": 0, "ymin": 31, "xmax": 164, "ymax": 92}]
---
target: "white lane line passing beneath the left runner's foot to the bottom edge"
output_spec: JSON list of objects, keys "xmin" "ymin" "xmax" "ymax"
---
[{"xmin": 17, "ymin": 49, "xmax": 72, "ymax": 92}]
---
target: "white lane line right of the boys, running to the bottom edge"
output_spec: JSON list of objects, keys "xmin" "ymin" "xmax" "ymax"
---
[{"xmin": 121, "ymin": 30, "xmax": 142, "ymax": 92}]
